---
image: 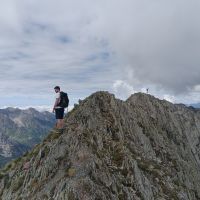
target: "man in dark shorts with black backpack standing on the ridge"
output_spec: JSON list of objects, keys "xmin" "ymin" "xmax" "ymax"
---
[{"xmin": 53, "ymin": 86, "xmax": 69, "ymax": 129}]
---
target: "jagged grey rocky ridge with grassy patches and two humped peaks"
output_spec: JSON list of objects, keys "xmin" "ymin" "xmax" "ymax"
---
[{"xmin": 0, "ymin": 92, "xmax": 200, "ymax": 200}]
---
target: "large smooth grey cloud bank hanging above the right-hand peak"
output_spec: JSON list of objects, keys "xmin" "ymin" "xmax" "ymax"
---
[{"xmin": 91, "ymin": 0, "xmax": 200, "ymax": 94}]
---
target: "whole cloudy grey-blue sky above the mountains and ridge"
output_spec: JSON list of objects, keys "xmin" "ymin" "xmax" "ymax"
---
[{"xmin": 0, "ymin": 0, "xmax": 200, "ymax": 108}]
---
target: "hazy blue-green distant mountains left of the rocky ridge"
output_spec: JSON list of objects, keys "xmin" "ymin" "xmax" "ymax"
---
[{"xmin": 0, "ymin": 107, "xmax": 55, "ymax": 167}]
